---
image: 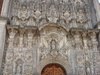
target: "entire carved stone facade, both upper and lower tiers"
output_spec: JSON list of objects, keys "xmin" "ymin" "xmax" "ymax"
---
[{"xmin": 3, "ymin": 0, "xmax": 100, "ymax": 75}]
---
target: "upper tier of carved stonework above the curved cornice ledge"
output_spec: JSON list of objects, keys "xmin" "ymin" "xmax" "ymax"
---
[{"xmin": 11, "ymin": 0, "xmax": 92, "ymax": 28}]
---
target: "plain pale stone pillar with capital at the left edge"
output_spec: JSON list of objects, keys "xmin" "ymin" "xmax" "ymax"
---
[{"xmin": 0, "ymin": 17, "xmax": 7, "ymax": 75}]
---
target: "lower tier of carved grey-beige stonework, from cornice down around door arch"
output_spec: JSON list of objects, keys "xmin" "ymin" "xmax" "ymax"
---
[{"xmin": 4, "ymin": 26, "xmax": 99, "ymax": 75}]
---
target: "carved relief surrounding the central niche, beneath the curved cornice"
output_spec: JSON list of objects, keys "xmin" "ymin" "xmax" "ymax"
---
[{"xmin": 40, "ymin": 28, "xmax": 69, "ymax": 60}]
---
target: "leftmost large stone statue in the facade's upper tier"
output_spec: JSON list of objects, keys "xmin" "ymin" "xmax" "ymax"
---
[{"xmin": 19, "ymin": 5, "xmax": 29, "ymax": 20}]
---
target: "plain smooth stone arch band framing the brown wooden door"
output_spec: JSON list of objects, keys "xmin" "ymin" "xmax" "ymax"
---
[{"xmin": 37, "ymin": 59, "xmax": 71, "ymax": 75}]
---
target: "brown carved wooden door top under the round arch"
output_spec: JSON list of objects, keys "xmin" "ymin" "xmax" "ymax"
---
[{"xmin": 41, "ymin": 64, "xmax": 66, "ymax": 75}]
